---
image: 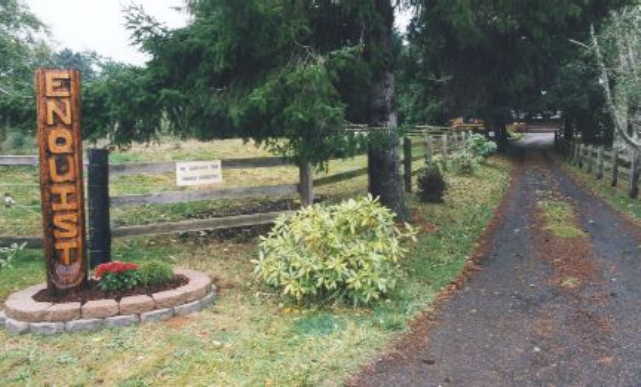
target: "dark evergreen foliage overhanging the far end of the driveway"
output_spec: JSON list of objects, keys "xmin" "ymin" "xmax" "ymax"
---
[{"xmin": 410, "ymin": 0, "xmax": 628, "ymax": 146}]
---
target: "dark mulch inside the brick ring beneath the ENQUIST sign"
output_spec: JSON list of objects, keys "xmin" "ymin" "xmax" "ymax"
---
[{"xmin": 33, "ymin": 274, "xmax": 189, "ymax": 304}]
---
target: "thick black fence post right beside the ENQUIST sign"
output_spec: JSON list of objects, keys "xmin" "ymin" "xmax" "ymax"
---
[{"xmin": 88, "ymin": 149, "xmax": 111, "ymax": 268}]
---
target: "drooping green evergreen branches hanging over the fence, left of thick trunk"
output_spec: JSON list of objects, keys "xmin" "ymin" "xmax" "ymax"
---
[{"xmin": 121, "ymin": 0, "xmax": 407, "ymax": 218}]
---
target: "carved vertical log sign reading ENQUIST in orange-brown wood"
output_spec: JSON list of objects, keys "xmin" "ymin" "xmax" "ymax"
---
[{"xmin": 36, "ymin": 69, "xmax": 87, "ymax": 293}]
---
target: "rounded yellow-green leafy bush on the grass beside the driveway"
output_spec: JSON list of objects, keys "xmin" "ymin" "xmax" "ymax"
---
[{"xmin": 254, "ymin": 196, "xmax": 415, "ymax": 305}]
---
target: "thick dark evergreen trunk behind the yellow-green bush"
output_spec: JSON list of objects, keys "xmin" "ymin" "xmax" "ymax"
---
[{"xmin": 366, "ymin": 0, "xmax": 409, "ymax": 221}]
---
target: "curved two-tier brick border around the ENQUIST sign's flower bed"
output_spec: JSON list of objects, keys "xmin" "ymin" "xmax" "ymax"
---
[{"xmin": 0, "ymin": 269, "xmax": 216, "ymax": 335}]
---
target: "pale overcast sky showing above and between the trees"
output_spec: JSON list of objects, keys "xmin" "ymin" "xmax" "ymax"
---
[{"xmin": 26, "ymin": 0, "xmax": 409, "ymax": 65}]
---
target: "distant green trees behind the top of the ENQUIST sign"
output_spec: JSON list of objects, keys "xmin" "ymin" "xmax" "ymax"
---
[{"xmin": 0, "ymin": 0, "xmax": 135, "ymax": 150}]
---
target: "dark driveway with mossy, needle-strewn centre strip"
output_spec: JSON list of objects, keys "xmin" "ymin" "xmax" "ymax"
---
[{"xmin": 353, "ymin": 136, "xmax": 641, "ymax": 386}]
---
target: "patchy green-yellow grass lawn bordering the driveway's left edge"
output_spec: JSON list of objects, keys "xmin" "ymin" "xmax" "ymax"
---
[{"xmin": 0, "ymin": 139, "xmax": 511, "ymax": 386}]
